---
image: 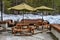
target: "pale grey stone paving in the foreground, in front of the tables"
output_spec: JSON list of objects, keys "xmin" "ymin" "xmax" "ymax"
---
[{"xmin": 0, "ymin": 32, "xmax": 53, "ymax": 40}]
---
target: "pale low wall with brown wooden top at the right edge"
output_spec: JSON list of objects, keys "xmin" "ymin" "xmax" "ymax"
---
[{"xmin": 51, "ymin": 24, "xmax": 60, "ymax": 40}]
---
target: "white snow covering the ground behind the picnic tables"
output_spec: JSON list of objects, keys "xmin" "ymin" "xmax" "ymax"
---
[{"xmin": 0, "ymin": 13, "xmax": 60, "ymax": 24}]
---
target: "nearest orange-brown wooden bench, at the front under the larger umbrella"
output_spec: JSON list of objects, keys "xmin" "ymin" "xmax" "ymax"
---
[{"xmin": 12, "ymin": 25, "xmax": 34, "ymax": 35}]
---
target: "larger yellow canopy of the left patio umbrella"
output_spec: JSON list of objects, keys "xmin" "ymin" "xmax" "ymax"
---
[{"xmin": 8, "ymin": 3, "xmax": 35, "ymax": 11}]
